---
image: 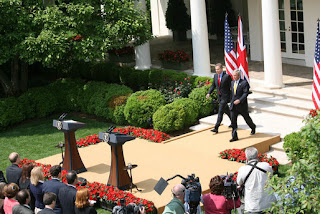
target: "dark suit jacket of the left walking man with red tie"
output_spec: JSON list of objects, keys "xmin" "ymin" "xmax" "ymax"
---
[{"xmin": 208, "ymin": 71, "xmax": 232, "ymax": 102}]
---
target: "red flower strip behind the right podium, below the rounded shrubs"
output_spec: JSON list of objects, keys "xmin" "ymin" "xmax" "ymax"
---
[{"xmin": 114, "ymin": 126, "xmax": 170, "ymax": 143}]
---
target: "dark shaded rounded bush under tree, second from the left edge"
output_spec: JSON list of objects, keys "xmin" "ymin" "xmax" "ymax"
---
[{"xmin": 18, "ymin": 87, "xmax": 57, "ymax": 118}]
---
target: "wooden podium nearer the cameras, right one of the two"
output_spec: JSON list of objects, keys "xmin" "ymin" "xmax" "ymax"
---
[{"xmin": 99, "ymin": 132, "xmax": 136, "ymax": 190}]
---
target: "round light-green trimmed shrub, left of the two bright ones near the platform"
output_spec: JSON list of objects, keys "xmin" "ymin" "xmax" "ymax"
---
[{"xmin": 124, "ymin": 89, "xmax": 166, "ymax": 127}]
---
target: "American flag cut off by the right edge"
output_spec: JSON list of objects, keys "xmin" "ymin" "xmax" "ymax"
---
[{"xmin": 312, "ymin": 19, "xmax": 320, "ymax": 109}]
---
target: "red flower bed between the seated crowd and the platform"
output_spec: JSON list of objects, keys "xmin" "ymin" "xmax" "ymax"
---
[{"xmin": 19, "ymin": 159, "xmax": 155, "ymax": 213}]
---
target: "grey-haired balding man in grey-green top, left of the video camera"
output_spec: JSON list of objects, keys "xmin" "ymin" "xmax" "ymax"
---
[{"xmin": 163, "ymin": 184, "xmax": 186, "ymax": 214}]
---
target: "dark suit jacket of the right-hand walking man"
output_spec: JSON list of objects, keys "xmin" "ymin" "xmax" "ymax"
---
[{"xmin": 230, "ymin": 79, "xmax": 249, "ymax": 112}]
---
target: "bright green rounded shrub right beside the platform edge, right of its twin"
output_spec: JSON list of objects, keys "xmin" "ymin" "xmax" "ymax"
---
[{"xmin": 153, "ymin": 98, "xmax": 199, "ymax": 133}]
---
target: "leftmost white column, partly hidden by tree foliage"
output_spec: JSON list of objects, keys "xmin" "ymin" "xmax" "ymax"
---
[{"xmin": 134, "ymin": 0, "xmax": 151, "ymax": 70}]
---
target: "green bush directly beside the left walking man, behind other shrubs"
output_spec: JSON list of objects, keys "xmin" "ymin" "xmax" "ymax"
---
[{"xmin": 189, "ymin": 85, "xmax": 218, "ymax": 117}]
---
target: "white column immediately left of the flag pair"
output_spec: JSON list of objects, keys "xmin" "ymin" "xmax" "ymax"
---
[{"xmin": 190, "ymin": 0, "xmax": 211, "ymax": 77}]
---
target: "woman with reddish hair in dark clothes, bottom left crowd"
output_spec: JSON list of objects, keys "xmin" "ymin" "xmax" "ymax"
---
[{"xmin": 75, "ymin": 188, "xmax": 97, "ymax": 214}]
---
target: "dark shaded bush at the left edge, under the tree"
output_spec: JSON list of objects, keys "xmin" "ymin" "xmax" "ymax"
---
[{"xmin": 0, "ymin": 97, "xmax": 24, "ymax": 130}]
